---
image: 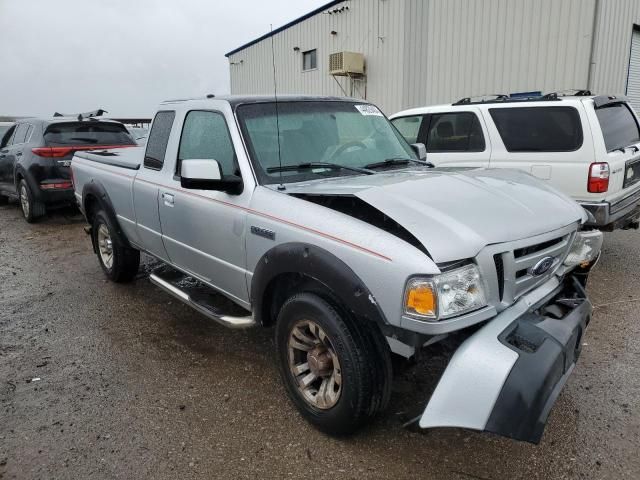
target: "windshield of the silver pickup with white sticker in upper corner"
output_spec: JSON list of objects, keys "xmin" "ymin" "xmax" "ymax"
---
[{"xmin": 237, "ymin": 101, "xmax": 416, "ymax": 184}]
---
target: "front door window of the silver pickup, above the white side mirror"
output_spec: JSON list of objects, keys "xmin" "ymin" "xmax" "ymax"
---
[{"xmin": 176, "ymin": 110, "xmax": 236, "ymax": 175}]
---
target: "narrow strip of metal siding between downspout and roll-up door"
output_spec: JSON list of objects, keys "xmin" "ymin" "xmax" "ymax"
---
[{"xmin": 592, "ymin": 0, "xmax": 640, "ymax": 95}]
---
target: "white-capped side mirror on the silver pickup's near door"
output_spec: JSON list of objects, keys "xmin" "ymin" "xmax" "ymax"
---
[{"xmin": 180, "ymin": 158, "xmax": 243, "ymax": 195}]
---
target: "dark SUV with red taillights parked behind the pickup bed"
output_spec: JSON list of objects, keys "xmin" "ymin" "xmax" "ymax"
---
[{"xmin": 0, "ymin": 116, "xmax": 136, "ymax": 222}]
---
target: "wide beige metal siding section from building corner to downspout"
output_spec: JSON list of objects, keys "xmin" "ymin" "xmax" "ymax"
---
[{"xmin": 402, "ymin": 0, "xmax": 595, "ymax": 107}]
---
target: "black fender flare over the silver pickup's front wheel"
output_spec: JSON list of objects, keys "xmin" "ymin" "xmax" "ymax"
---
[{"xmin": 251, "ymin": 243, "xmax": 387, "ymax": 327}]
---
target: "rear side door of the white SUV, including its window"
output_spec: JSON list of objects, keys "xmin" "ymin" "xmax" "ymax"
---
[{"xmin": 418, "ymin": 107, "xmax": 491, "ymax": 167}]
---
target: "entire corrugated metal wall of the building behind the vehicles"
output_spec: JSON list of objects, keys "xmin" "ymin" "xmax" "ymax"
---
[{"xmin": 229, "ymin": 0, "xmax": 640, "ymax": 113}]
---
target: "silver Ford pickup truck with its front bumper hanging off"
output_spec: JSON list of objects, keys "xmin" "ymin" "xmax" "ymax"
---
[{"xmin": 72, "ymin": 96, "xmax": 602, "ymax": 442}]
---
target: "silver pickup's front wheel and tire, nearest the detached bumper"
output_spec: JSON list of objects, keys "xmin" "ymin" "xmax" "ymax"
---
[{"xmin": 276, "ymin": 292, "xmax": 392, "ymax": 435}]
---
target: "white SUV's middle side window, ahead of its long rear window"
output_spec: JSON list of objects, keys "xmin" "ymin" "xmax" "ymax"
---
[{"xmin": 424, "ymin": 112, "xmax": 485, "ymax": 152}]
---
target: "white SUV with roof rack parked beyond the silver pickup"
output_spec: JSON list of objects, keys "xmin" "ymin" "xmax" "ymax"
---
[{"xmin": 391, "ymin": 92, "xmax": 640, "ymax": 230}]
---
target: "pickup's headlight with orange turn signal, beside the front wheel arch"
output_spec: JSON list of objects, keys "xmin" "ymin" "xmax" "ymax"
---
[{"xmin": 404, "ymin": 265, "xmax": 487, "ymax": 320}]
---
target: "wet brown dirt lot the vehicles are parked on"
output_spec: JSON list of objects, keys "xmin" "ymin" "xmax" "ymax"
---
[{"xmin": 0, "ymin": 201, "xmax": 640, "ymax": 480}]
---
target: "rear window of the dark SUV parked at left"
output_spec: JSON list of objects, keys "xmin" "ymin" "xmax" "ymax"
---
[{"xmin": 44, "ymin": 120, "xmax": 136, "ymax": 146}]
